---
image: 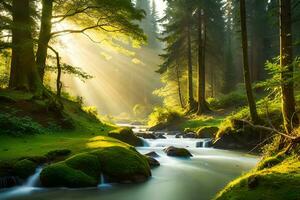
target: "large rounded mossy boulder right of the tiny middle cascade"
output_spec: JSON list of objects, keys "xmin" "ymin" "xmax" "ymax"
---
[{"xmin": 93, "ymin": 146, "xmax": 151, "ymax": 183}]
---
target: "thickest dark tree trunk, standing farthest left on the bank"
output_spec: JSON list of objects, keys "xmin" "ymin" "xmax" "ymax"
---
[{"xmin": 9, "ymin": 0, "xmax": 42, "ymax": 93}]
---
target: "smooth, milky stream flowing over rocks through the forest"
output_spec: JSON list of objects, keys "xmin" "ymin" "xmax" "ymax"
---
[{"xmin": 0, "ymin": 126, "xmax": 259, "ymax": 200}]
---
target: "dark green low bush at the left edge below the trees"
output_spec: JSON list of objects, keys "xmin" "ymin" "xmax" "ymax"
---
[{"xmin": 0, "ymin": 113, "xmax": 43, "ymax": 136}]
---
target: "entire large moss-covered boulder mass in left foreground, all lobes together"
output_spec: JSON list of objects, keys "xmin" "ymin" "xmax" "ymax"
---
[{"xmin": 40, "ymin": 146, "xmax": 151, "ymax": 188}]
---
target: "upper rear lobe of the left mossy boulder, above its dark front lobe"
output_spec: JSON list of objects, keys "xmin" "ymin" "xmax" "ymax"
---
[{"xmin": 65, "ymin": 153, "xmax": 101, "ymax": 179}]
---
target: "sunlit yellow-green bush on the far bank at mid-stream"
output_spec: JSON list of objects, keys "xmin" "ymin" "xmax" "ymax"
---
[{"xmin": 148, "ymin": 107, "xmax": 183, "ymax": 126}]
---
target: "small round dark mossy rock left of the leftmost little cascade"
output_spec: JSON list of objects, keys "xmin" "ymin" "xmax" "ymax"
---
[{"xmin": 14, "ymin": 159, "xmax": 37, "ymax": 179}]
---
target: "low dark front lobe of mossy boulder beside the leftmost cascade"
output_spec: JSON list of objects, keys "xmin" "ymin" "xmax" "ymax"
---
[{"xmin": 40, "ymin": 162, "xmax": 98, "ymax": 188}]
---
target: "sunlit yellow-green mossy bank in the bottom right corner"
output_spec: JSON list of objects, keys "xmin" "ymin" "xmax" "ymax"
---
[{"xmin": 215, "ymin": 157, "xmax": 300, "ymax": 200}]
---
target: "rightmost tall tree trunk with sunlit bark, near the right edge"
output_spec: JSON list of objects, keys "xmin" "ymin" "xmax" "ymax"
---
[{"xmin": 279, "ymin": 0, "xmax": 299, "ymax": 133}]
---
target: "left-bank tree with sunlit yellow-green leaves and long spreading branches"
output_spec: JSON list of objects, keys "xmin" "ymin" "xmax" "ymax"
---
[{"xmin": 36, "ymin": 0, "xmax": 145, "ymax": 80}]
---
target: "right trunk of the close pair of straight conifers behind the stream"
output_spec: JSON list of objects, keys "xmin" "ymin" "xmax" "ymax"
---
[{"xmin": 197, "ymin": 9, "xmax": 208, "ymax": 115}]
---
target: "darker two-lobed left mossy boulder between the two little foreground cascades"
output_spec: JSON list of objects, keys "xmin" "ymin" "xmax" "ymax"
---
[{"xmin": 40, "ymin": 153, "xmax": 101, "ymax": 188}]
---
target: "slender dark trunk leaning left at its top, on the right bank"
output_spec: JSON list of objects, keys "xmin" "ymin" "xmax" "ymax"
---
[{"xmin": 240, "ymin": 0, "xmax": 259, "ymax": 123}]
